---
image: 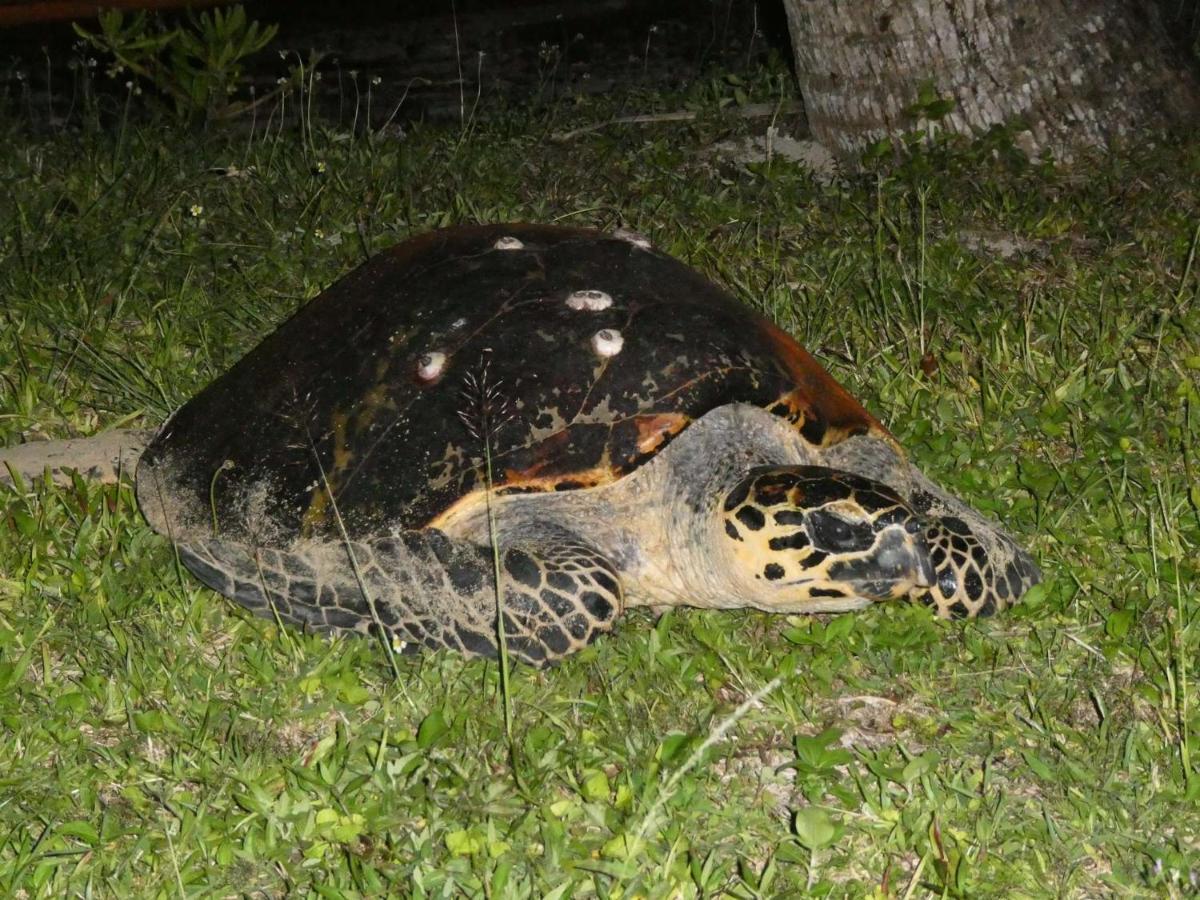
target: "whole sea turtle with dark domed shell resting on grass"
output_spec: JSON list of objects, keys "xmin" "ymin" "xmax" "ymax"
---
[{"xmin": 2, "ymin": 224, "xmax": 1039, "ymax": 665}]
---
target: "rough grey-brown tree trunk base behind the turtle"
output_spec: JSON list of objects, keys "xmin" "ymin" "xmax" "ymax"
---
[{"xmin": 784, "ymin": 0, "xmax": 1200, "ymax": 161}]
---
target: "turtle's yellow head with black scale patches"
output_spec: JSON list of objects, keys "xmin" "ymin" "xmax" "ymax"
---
[{"xmin": 721, "ymin": 466, "xmax": 935, "ymax": 612}]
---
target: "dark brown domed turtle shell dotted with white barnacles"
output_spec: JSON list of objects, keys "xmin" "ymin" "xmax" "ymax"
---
[{"xmin": 138, "ymin": 224, "xmax": 886, "ymax": 544}]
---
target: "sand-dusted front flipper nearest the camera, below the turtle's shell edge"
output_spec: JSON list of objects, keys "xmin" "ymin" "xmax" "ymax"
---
[{"xmin": 179, "ymin": 529, "xmax": 624, "ymax": 666}]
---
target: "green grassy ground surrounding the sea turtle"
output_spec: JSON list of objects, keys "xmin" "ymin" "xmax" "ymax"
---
[{"xmin": 0, "ymin": 60, "xmax": 1200, "ymax": 898}]
